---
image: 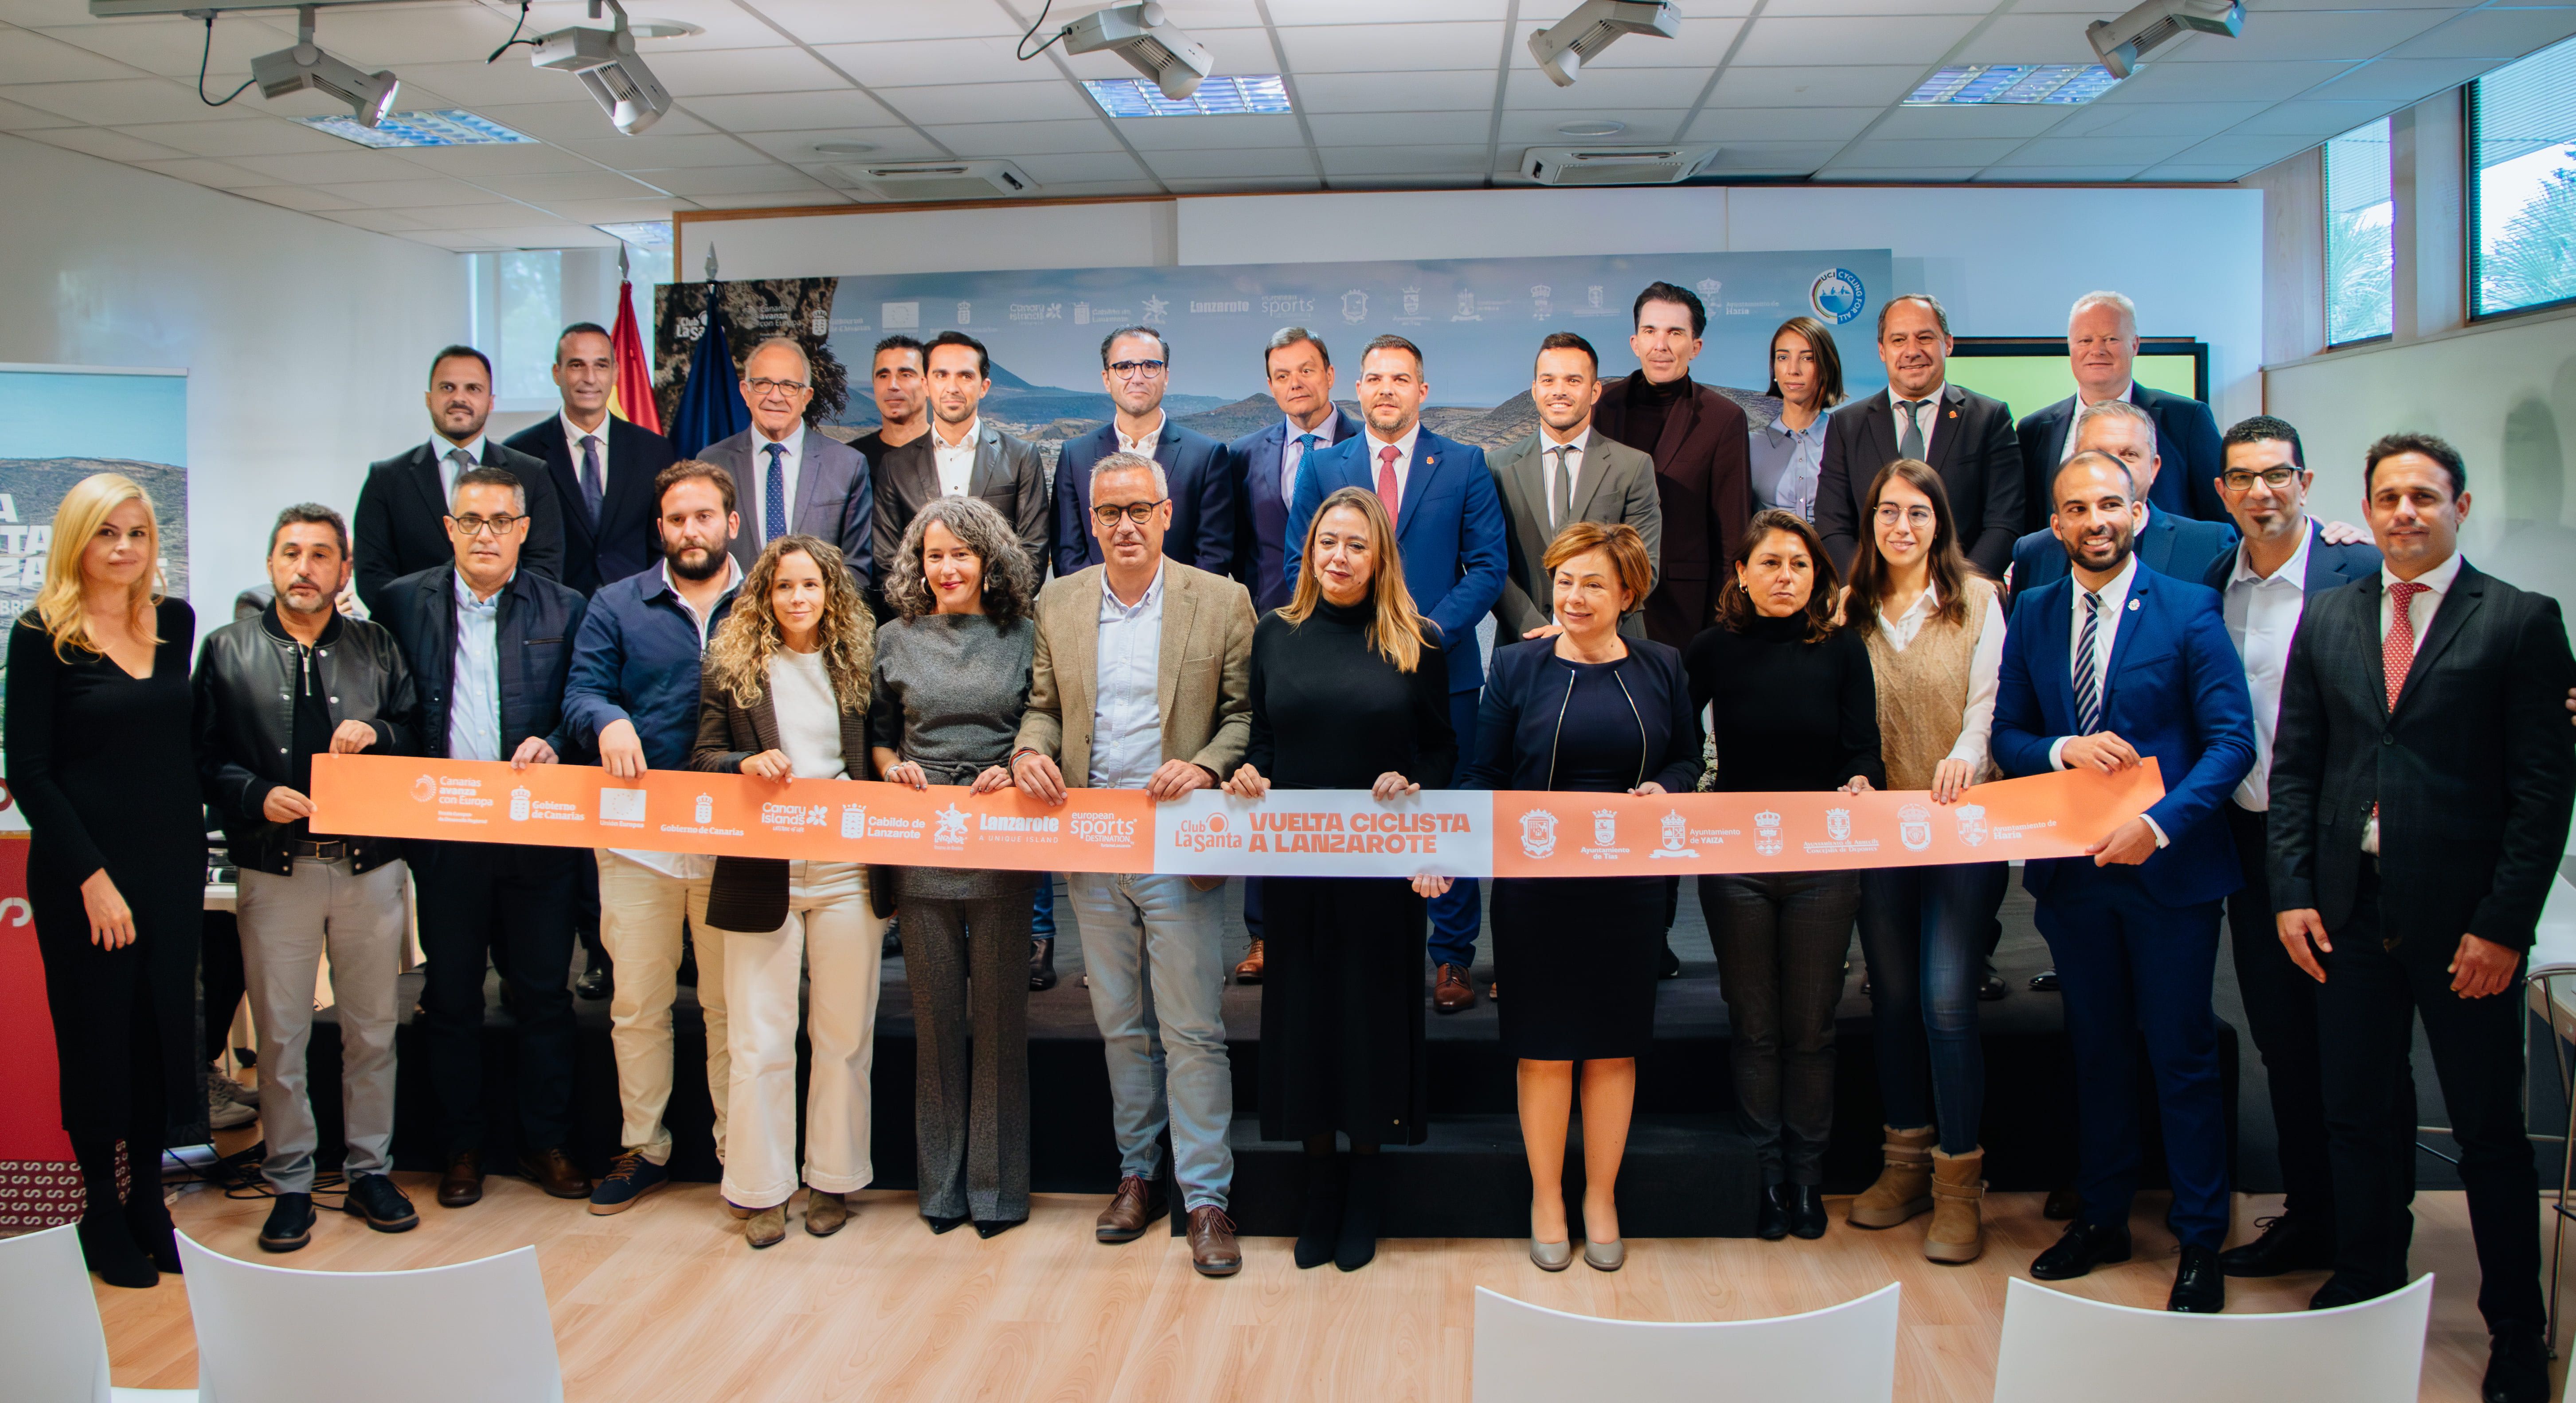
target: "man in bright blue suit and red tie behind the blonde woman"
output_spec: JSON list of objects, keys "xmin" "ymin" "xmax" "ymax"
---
[{"xmin": 1288, "ymin": 335, "xmax": 1509, "ymax": 1014}]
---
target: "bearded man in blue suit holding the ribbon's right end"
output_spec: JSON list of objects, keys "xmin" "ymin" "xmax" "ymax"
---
[{"xmin": 1994, "ymin": 453, "xmax": 2254, "ymax": 1313}]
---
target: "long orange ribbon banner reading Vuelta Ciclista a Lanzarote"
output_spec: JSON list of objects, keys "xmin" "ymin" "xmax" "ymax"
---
[{"xmin": 312, "ymin": 754, "xmax": 2164, "ymax": 878}]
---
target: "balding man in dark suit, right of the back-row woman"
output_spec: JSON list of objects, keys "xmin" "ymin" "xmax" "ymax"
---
[{"xmin": 1816, "ymin": 293, "xmax": 2022, "ymax": 579}]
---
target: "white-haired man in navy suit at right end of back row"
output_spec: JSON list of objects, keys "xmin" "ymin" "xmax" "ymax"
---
[{"xmin": 2020, "ymin": 293, "xmax": 2228, "ymax": 530}]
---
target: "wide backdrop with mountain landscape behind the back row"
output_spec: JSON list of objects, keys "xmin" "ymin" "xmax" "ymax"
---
[{"xmin": 654, "ymin": 249, "xmax": 1893, "ymax": 466}]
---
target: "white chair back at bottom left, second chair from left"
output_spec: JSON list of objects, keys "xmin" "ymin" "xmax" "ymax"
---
[{"xmin": 178, "ymin": 1233, "xmax": 564, "ymax": 1403}]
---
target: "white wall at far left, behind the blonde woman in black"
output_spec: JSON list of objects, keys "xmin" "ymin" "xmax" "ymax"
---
[{"xmin": 0, "ymin": 136, "xmax": 466, "ymax": 610}]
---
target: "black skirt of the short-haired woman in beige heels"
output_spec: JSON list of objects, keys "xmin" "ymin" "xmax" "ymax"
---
[{"xmin": 1492, "ymin": 878, "xmax": 1664, "ymax": 1060}]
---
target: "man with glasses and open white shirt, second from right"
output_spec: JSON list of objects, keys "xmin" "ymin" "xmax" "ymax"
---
[{"xmin": 2200, "ymin": 417, "xmax": 2380, "ymax": 1277}]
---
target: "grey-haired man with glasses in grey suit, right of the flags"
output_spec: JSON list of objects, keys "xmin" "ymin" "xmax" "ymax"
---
[{"xmin": 698, "ymin": 337, "xmax": 876, "ymax": 585}]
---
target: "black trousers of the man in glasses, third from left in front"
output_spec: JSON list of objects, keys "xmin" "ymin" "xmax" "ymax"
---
[{"xmin": 412, "ymin": 842, "xmax": 587, "ymax": 1154}]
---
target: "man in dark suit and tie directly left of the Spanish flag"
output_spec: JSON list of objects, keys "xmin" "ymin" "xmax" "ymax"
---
[{"xmin": 502, "ymin": 322, "xmax": 672, "ymax": 600}]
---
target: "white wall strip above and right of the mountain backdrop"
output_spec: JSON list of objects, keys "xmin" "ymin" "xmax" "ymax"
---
[{"xmin": 695, "ymin": 185, "xmax": 2262, "ymax": 422}]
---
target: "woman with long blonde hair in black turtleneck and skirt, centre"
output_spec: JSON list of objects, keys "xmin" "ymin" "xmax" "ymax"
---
[{"xmin": 1226, "ymin": 487, "xmax": 1474, "ymax": 1272}]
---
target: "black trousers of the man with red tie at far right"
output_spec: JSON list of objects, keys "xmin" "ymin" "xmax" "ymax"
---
[{"xmin": 2316, "ymin": 862, "xmax": 2545, "ymax": 1333}]
